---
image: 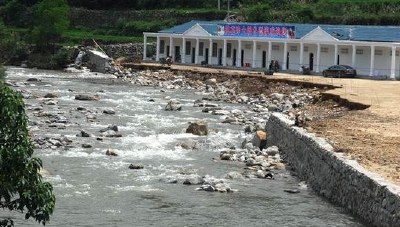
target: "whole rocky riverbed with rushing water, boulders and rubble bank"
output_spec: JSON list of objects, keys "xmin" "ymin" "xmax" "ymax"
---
[{"xmin": 3, "ymin": 68, "xmax": 362, "ymax": 226}]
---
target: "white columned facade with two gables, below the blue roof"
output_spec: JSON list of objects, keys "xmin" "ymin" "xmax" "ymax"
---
[{"xmin": 143, "ymin": 24, "xmax": 400, "ymax": 78}]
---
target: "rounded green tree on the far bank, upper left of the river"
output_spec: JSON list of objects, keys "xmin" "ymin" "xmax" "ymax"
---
[{"xmin": 32, "ymin": 0, "xmax": 70, "ymax": 51}]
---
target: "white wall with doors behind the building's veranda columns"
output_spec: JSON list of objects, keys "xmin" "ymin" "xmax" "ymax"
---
[{"xmin": 152, "ymin": 37, "xmax": 400, "ymax": 76}]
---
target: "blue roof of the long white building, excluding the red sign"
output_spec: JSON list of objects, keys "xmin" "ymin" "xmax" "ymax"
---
[{"xmin": 159, "ymin": 21, "xmax": 400, "ymax": 42}]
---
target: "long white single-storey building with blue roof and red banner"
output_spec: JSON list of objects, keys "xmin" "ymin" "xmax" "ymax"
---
[{"xmin": 143, "ymin": 21, "xmax": 400, "ymax": 78}]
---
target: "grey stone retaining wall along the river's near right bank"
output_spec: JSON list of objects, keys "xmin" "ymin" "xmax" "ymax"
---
[{"xmin": 266, "ymin": 114, "xmax": 400, "ymax": 227}]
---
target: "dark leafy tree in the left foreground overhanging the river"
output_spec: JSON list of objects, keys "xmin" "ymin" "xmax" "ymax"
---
[{"xmin": 0, "ymin": 82, "xmax": 55, "ymax": 226}]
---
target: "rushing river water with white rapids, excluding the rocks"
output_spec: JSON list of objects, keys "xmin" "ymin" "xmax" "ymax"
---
[{"xmin": 0, "ymin": 68, "xmax": 364, "ymax": 227}]
